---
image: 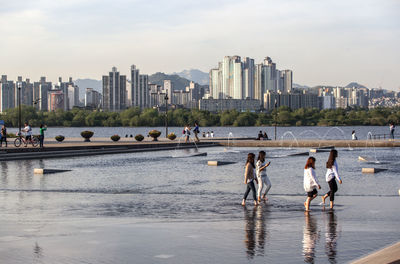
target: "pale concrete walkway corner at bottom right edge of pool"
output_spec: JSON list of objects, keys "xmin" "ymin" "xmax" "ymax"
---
[{"xmin": 351, "ymin": 242, "xmax": 400, "ymax": 264}]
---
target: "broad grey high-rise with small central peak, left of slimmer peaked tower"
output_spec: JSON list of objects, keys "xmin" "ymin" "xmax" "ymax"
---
[{"xmin": 102, "ymin": 67, "xmax": 127, "ymax": 111}]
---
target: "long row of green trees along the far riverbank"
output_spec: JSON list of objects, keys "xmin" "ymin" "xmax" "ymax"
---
[{"xmin": 0, "ymin": 106, "xmax": 400, "ymax": 127}]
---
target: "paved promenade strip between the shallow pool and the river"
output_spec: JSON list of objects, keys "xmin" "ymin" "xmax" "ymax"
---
[{"xmin": 0, "ymin": 138, "xmax": 400, "ymax": 161}]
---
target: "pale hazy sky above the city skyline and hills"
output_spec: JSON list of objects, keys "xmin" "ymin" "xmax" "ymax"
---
[{"xmin": 0, "ymin": 0, "xmax": 400, "ymax": 91}]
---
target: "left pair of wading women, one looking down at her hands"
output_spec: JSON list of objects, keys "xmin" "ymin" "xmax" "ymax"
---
[{"xmin": 242, "ymin": 151, "xmax": 272, "ymax": 205}]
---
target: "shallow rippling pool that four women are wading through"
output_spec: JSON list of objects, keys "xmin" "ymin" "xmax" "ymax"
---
[{"xmin": 0, "ymin": 145, "xmax": 400, "ymax": 263}]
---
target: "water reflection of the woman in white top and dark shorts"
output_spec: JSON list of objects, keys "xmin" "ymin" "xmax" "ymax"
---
[{"xmin": 303, "ymin": 212, "xmax": 319, "ymax": 263}]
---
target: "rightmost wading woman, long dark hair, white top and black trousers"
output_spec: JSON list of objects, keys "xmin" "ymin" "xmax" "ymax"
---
[{"xmin": 322, "ymin": 149, "xmax": 342, "ymax": 209}]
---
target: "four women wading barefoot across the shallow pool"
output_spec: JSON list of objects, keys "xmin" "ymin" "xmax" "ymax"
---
[{"xmin": 242, "ymin": 149, "xmax": 342, "ymax": 211}]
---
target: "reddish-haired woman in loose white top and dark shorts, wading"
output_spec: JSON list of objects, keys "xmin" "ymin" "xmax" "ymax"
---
[{"xmin": 303, "ymin": 157, "xmax": 321, "ymax": 212}]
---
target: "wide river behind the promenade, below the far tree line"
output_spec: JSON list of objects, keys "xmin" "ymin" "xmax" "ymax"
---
[{"xmin": 8, "ymin": 126, "xmax": 389, "ymax": 139}]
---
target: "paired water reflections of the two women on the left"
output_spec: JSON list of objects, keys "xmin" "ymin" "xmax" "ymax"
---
[{"xmin": 244, "ymin": 206, "xmax": 268, "ymax": 259}]
